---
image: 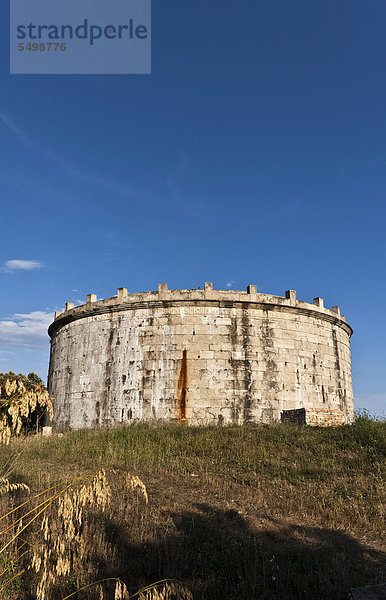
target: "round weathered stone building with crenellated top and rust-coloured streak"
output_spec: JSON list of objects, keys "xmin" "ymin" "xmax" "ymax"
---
[{"xmin": 49, "ymin": 284, "xmax": 353, "ymax": 428}]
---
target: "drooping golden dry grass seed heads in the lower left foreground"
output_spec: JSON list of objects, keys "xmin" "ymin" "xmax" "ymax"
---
[{"xmin": 0, "ymin": 469, "xmax": 148, "ymax": 600}]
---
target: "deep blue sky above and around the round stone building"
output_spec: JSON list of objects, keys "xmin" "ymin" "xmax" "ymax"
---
[{"xmin": 0, "ymin": 0, "xmax": 386, "ymax": 414}]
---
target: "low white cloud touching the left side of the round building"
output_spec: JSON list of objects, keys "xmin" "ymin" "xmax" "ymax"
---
[{"xmin": 0, "ymin": 311, "xmax": 53, "ymax": 350}]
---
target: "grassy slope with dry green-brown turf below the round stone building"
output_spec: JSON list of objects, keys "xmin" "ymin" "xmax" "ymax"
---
[{"xmin": 0, "ymin": 417, "xmax": 386, "ymax": 600}]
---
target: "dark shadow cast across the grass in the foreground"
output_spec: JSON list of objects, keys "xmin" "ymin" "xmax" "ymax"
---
[{"xmin": 91, "ymin": 504, "xmax": 385, "ymax": 600}]
